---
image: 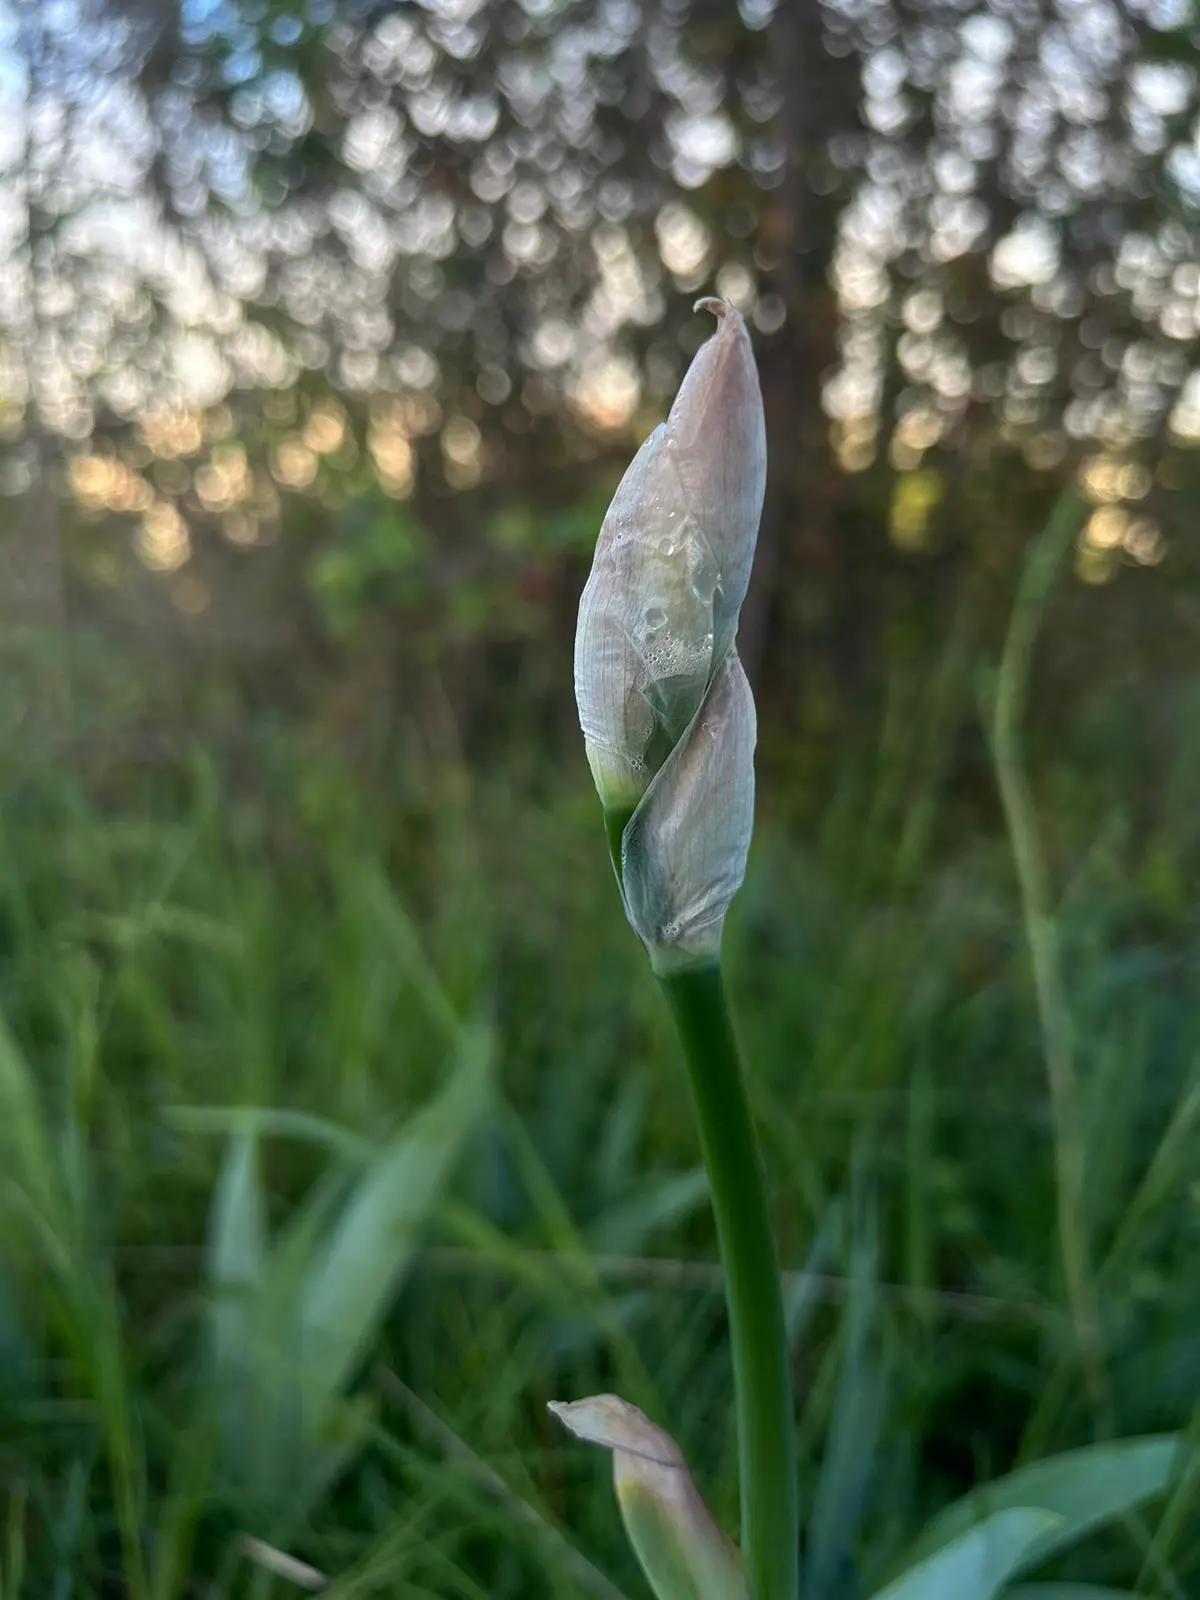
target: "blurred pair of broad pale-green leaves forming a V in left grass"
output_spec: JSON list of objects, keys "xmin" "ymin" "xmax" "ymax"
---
[{"xmin": 202, "ymin": 1029, "xmax": 491, "ymax": 1528}]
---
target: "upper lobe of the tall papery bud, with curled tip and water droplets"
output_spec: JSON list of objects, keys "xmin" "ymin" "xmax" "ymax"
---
[{"xmin": 574, "ymin": 299, "xmax": 766, "ymax": 811}]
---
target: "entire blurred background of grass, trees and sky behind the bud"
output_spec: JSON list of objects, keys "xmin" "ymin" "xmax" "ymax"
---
[{"xmin": 0, "ymin": 0, "xmax": 1200, "ymax": 1600}]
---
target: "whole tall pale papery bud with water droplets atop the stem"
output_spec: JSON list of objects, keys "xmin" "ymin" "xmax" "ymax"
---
[{"xmin": 574, "ymin": 299, "xmax": 766, "ymax": 970}]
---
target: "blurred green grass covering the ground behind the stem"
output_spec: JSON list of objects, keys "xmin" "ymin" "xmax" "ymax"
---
[{"xmin": 0, "ymin": 585, "xmax": 1200, "ymax": 1600}]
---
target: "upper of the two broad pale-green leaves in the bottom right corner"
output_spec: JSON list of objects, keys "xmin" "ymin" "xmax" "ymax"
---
[{"xmin": 909, "ymin": 1434, "xmax": 1179, "ymax": 1568}]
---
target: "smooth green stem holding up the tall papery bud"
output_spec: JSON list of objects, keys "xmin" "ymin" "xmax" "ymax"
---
[{"xmin": 659, "ymin": 963, "xmax": 800, "ymax": 1600}]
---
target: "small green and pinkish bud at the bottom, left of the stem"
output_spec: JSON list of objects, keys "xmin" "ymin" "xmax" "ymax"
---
[{"xmin": 550, "ymin": 1395, "xmax": 749, "ymax": 1600}]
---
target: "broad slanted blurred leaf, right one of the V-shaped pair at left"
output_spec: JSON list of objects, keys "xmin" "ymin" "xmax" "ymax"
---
[{"xmin": 299, "ymin": 1027, "xmax": 491, "ymax": 1418}]
